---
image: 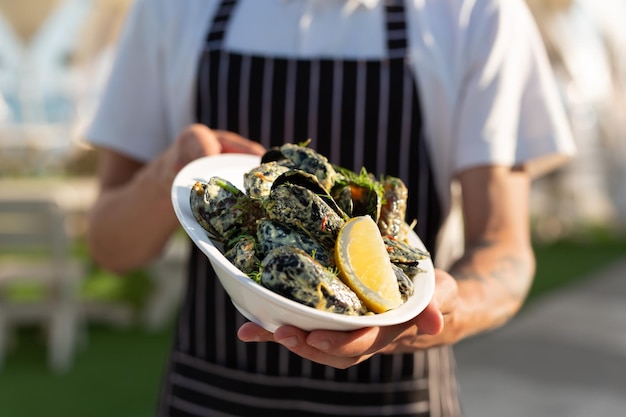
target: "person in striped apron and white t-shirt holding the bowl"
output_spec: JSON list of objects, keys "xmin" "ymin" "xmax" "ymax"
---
[{"xmin": 88, "ymin": 0, "xmax": 574, "ymax": 417}]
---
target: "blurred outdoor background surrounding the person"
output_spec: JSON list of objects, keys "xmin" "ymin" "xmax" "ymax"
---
[{"xmin": 0, "ymin": 0, "xmax": 626, "ymax": 417}]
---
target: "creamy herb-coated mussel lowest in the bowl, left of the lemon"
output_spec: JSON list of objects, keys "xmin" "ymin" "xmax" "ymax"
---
[{"xmin": 261, "ymin": 246, "xmax": 367, "ymax": 316}]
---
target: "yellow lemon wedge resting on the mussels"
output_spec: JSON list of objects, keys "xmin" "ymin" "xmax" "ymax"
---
[{"xmin": 335, "ymin": 215, "xmax": 403, "ymax": 313}]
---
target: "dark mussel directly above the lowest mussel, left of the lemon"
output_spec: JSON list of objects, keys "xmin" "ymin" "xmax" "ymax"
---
[{"xmin": 257, "ymin": 219, "xmax": 335, "ymax": 266}]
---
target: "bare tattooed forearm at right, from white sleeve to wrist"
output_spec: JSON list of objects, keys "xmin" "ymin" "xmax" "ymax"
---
[{"xmin": 394, "ymin": 167, "xmax": 535, "ymax": 348}]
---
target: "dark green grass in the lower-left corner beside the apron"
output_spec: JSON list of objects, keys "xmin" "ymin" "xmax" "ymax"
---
[{"xmin": 0, "ymin": 327, "xmax": 171, "ymax": 417}]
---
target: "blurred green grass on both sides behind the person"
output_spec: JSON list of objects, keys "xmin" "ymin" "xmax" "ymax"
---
[{"xmin": 0, "ymin": 237, "xmax": 626, "ymax": 417}]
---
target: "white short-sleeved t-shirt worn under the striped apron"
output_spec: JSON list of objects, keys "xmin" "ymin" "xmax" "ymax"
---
[{"xmin": 87, "ymin": 0, "xmax": 574, "ymax": 260}]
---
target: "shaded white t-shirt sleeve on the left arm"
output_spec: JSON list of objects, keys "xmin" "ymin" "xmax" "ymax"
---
[{"xmin": 86, "ymin": 0, "xmax": 171, "ymax": 161}]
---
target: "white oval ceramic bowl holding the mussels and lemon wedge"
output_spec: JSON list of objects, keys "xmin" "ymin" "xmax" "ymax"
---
[{"xmin": 172, "ymin": 154, "xmax": 435, "ymax": 332}]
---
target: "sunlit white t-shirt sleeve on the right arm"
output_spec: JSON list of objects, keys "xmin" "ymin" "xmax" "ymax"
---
[{"xmin": 453, "ymin": 0, "xmax": 574, "ymax": 175}]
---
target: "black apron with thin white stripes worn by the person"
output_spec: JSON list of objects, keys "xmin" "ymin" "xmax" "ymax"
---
[{"xmin": 159, "ymin": 0, "xmax": 460, "ymax": 417}]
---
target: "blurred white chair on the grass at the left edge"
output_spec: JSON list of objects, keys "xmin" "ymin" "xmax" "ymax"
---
[{"xmin": 0, "ymin": 197, "xmax": 84, "ymax": 372}]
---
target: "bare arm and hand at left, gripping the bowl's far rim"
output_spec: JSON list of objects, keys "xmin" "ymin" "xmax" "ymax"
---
[{"xmin": 88, "ymin": 124, "xmax": 265, "ymax": 272}]
